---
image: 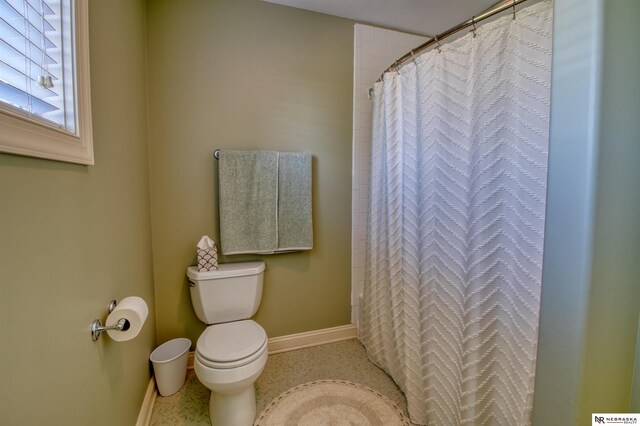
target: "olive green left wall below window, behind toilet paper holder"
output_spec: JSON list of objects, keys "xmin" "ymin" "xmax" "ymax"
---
[{"xmin": 0, "ymin": 0, "xmax": 156, "ymax": 425}]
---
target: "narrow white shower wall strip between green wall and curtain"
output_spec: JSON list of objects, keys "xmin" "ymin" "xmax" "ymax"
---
[{"xmin": 351, "ymin": 24, "xmax": 427, "ymax": 324}]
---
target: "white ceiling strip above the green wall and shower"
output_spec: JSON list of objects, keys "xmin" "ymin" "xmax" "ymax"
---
[{"xmin": 263, "ymin": 0, "xmax": 497, "ymax": 35}]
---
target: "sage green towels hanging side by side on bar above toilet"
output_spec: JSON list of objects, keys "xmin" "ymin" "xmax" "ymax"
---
[{"xmin": 218, "ymin": 150, "xmax": 313, "ymax": 254}]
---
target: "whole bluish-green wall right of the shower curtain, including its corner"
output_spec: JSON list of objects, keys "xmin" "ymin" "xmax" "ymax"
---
[{"xmin": 533, "ymin": 0, "xmax": 640, "ymax": 426}]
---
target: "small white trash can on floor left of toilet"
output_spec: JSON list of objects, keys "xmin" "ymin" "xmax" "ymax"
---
[{"xmin": 149, "ymin": 338, "xmax": 191, "ymax": 396}]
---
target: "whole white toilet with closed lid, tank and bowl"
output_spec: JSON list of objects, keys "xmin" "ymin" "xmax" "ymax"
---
[{"xmin": 187, "ymin": 262, "xmax": 267, "ymax": 426}]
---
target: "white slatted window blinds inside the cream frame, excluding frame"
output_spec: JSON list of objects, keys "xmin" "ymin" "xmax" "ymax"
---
[{"xmin": 0, "ymin": 0, "xmax": 77, "ymax": 133}]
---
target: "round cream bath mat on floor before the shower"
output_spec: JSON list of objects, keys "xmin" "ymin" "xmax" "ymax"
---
[{"xmin": 254, "ymin": 380, "xmax": 409, "ymax": 426}]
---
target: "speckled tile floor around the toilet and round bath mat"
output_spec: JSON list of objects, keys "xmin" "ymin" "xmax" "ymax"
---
[{"xmin": 151, "ymin": 339, "xmax": 416, "ymax": 426}]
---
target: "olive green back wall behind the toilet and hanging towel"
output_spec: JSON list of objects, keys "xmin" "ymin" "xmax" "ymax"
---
[{"xmin": 147, "ymin": 0, "xmax": 353, "ymax": 345}]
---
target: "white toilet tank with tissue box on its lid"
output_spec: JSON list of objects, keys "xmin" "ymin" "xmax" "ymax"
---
[{"xmin": 187, "ymin": 262, "xmax": 264, "ymax": 324}]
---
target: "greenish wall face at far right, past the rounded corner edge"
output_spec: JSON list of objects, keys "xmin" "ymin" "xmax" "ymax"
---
[{"xmin": 578, "ymin": 0, "xmax": 640, "ymax": 424}]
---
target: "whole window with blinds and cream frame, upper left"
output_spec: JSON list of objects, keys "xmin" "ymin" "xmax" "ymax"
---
[{"xmin": 0, "ymin": 0, "xmax": 93, "ymax": 164}]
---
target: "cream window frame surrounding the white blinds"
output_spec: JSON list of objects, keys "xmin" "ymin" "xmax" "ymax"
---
[{"xmin": 0, "ymin": 0, "xmax": 94, "ymax": 165}]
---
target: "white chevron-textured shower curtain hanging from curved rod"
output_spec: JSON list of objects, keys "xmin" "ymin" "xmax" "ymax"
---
[{"xmin": 359, "ymin": 1, "xmax": 552, "ymax": 426}]
